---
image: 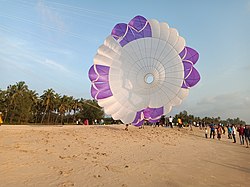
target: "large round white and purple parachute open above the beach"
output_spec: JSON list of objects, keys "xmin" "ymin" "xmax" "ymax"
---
[{"xmin": 89, "ymin": 16, "xmax": 200, "ymax": 126}]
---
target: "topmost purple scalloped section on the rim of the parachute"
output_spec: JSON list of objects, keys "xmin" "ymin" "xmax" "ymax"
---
[{"xmin": 111, "ymin": 16, "xmax": 152, "ymax": 47}]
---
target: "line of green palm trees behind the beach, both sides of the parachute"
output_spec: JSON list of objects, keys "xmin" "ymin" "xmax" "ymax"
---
[{"xmin": 0, "ymin": 81, "xmax": 246, "ymax": 125}]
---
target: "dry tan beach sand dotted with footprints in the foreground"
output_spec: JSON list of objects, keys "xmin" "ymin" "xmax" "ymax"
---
[{"xmin": 0, "ymin": 125, "xmax": 250, "ymax": 187}]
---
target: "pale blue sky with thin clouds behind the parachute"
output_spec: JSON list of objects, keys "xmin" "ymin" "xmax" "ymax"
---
[{"xmin": 0, "ymin": 0, "xmax": 250, "ymax": 124}]
